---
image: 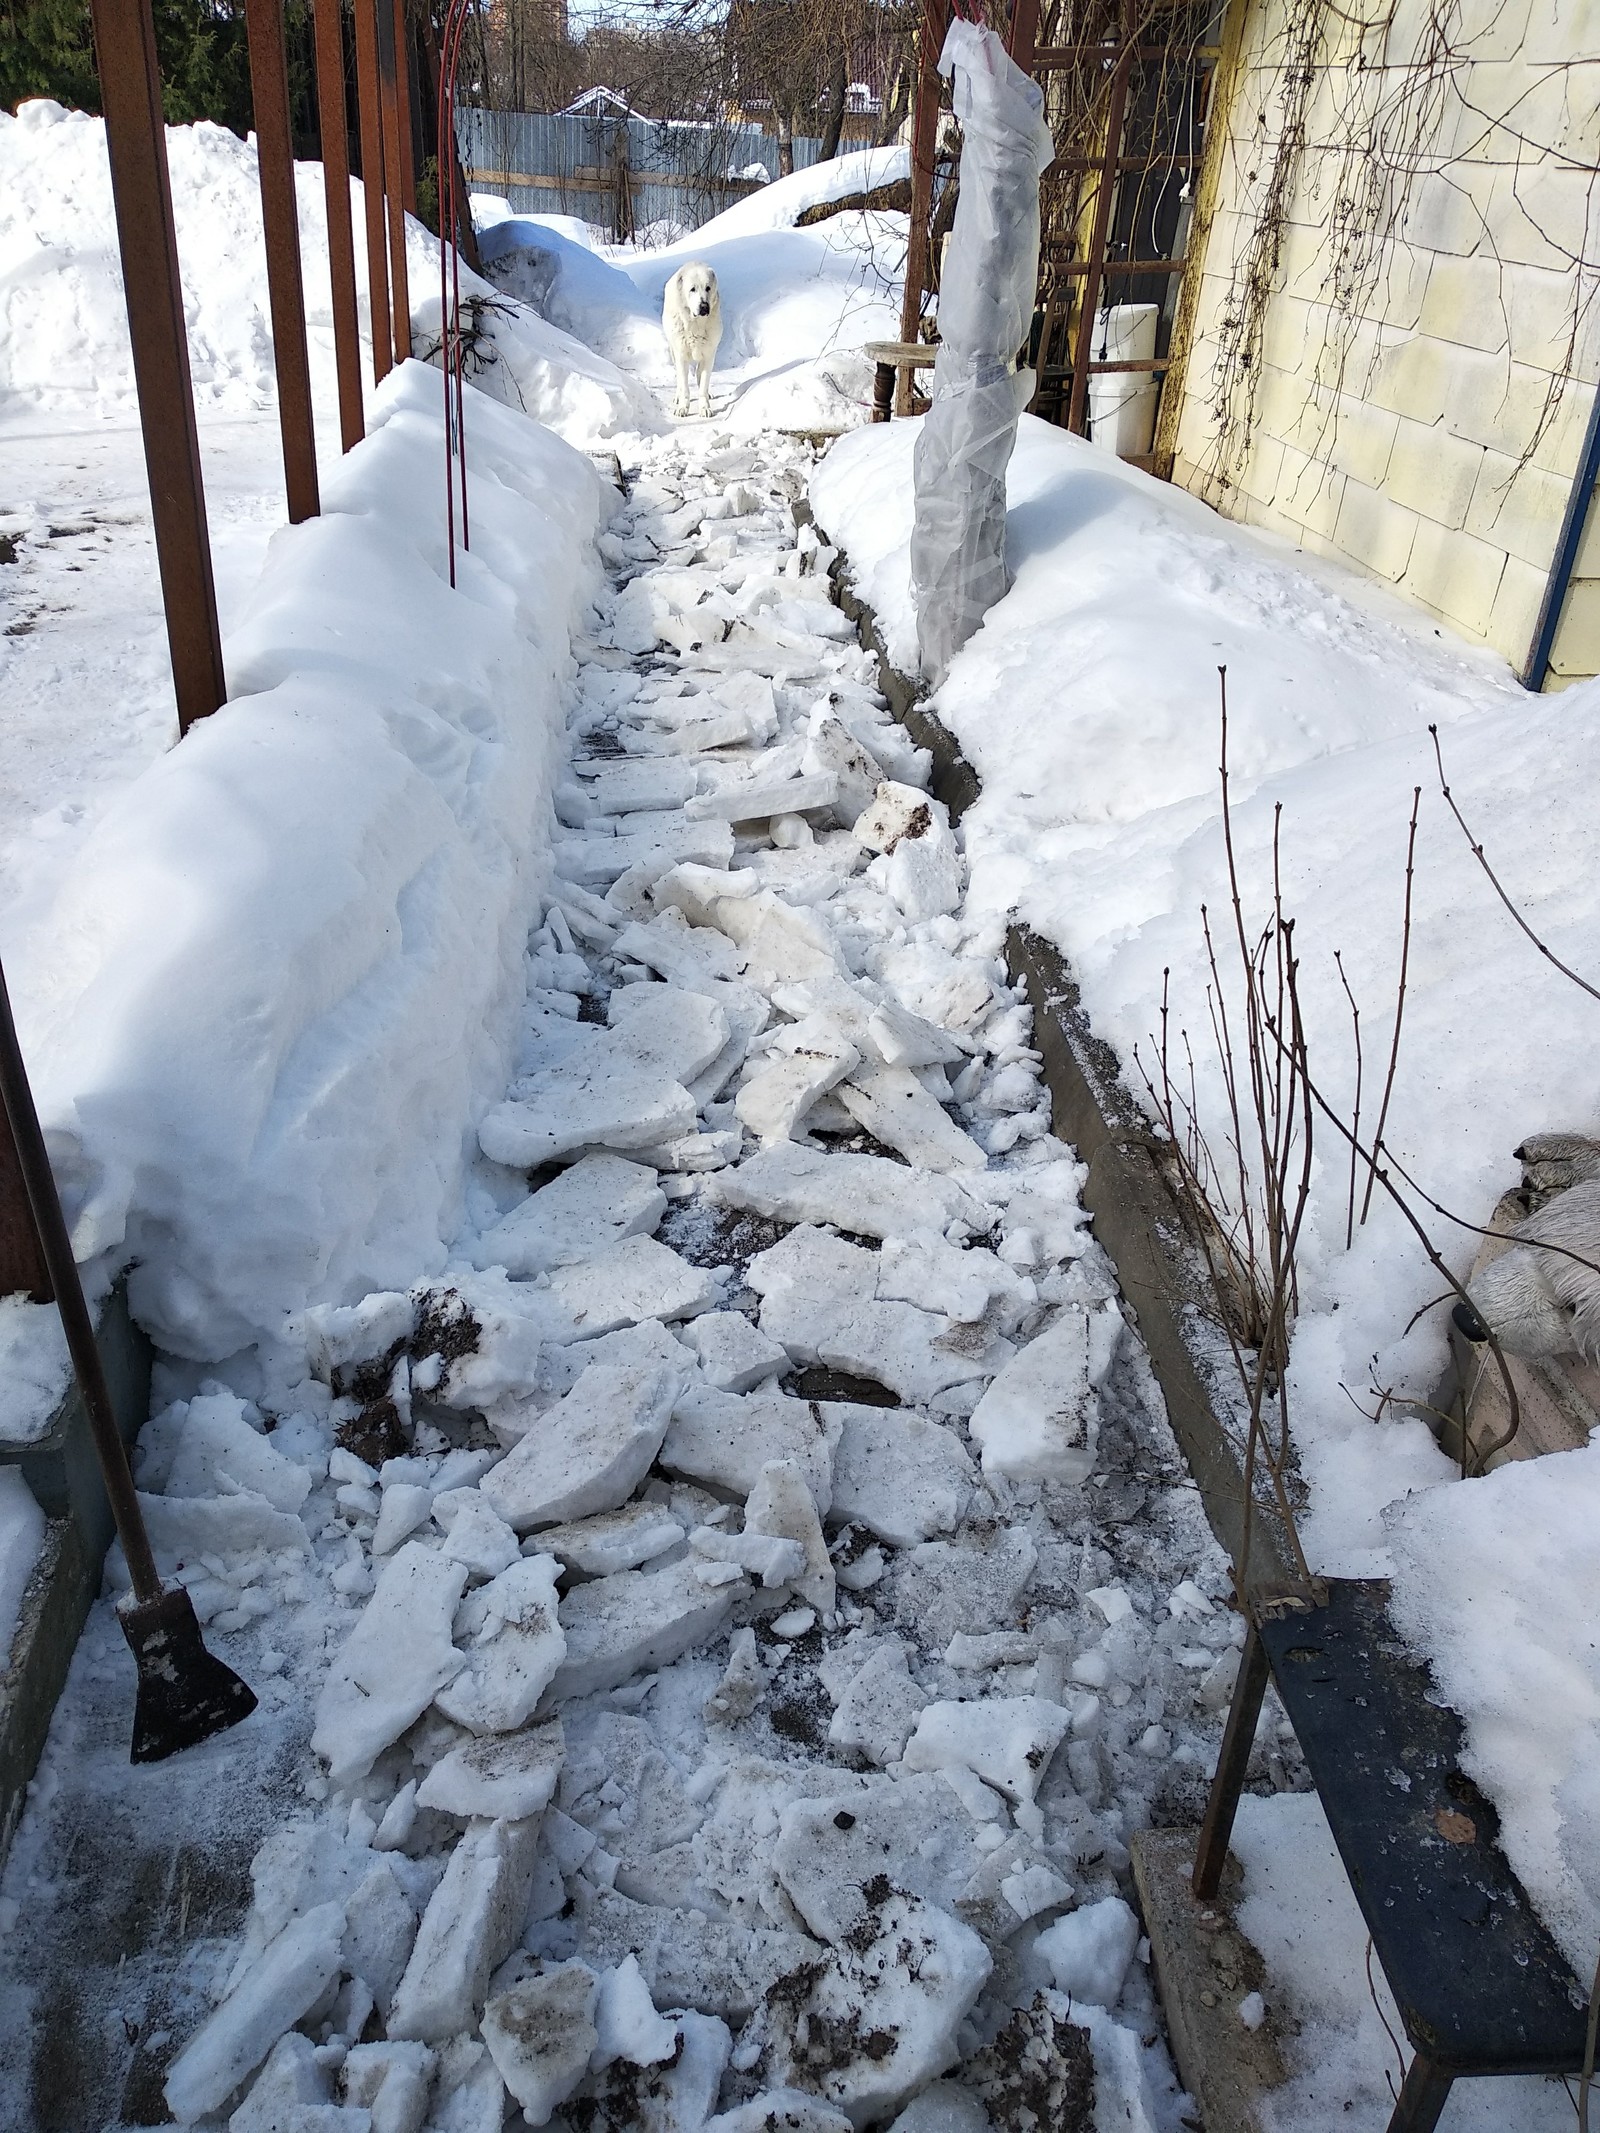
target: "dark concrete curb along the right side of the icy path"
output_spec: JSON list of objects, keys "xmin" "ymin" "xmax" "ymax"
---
[{"xmin": 832, "ymin": 550, "xmax": 1291, "ymax": 1589}]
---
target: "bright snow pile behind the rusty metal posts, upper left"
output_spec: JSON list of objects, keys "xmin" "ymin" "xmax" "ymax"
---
[{"xmin": 0, "ymin": 100, "xmax": 659, "ymax": 444}]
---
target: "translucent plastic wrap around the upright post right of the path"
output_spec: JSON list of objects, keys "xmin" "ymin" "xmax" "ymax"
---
[{"xmin": 911, "ymin": 21, "xmax": 1056, "ymax": 687}]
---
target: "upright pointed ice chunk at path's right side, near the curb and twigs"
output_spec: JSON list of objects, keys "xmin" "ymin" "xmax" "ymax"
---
[{"xmin": 969, "ymin": 1301, "xmax": 1122, "ymax": 1482}]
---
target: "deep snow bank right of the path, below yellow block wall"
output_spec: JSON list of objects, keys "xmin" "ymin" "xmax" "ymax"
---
[{"xmin": 813, "ymin": 420, "xmax": 1600, "ymax": 1975}]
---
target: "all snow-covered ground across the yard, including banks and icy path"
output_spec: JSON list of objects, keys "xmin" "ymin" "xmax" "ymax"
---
[{"xmin": 0, "ymin": 75, "xmax": 1600, "ymax": 2133}]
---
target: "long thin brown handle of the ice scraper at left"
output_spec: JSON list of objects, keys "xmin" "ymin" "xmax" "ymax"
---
[{"xmin": 0, "ymin": 951, "xmax": 162, "ymax": 1602}]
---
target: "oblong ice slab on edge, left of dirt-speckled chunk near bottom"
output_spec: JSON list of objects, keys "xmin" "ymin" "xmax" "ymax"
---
[{"xmin": 388, "ymin": 1822, "xmax": 540, "ymax": 2043}]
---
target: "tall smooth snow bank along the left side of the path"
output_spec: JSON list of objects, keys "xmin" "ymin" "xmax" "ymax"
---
[{"xmin": 23, "ymin": 365, "xmax": 602, "ymax": 1357}]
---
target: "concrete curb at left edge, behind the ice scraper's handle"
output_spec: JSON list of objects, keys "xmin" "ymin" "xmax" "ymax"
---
[{"xmin": 0, "ymin": 1284, "xmax": 151, "ymax": 1864}]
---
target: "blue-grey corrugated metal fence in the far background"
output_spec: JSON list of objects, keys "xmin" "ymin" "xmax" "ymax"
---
[{"xmin": 457, "ymin": 107, "xmax": 821, "ymax": 241}]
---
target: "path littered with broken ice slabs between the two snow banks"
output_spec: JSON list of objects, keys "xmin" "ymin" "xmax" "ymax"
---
[{"xmin": 0, "ymin": 424, "xmax": 1246, "ymax": 2133}]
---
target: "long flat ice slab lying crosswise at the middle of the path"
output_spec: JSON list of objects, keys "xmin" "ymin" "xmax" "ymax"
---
[{"xmin": 706, "ymin": 1145, "xmax": 992, "ymax": 1237}]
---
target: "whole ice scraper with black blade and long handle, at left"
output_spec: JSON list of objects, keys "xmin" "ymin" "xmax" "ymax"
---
[{"xmin": 0, "ymin": 971, "xmax": 256, "ymax": 1762}]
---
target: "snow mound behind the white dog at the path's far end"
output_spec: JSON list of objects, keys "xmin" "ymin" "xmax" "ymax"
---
[{"xmin": 478, "ymin": 149, "xmax": 907, "ymax": 433}]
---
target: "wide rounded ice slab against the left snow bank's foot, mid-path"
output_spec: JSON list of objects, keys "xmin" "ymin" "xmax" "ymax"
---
[{"xmin": 478, "ymin": 1043, "xmax": 695, "ymax": 1171}]
